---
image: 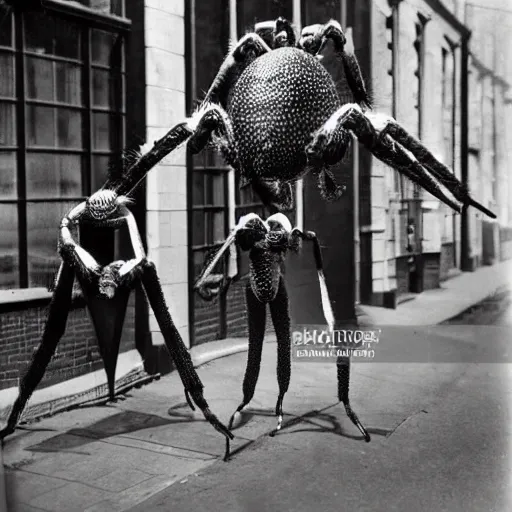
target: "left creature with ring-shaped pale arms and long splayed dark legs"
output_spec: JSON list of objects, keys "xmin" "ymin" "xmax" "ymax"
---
[{"xmin": 0, "ymin": 189, "xmax": 233, "ymax": 439}]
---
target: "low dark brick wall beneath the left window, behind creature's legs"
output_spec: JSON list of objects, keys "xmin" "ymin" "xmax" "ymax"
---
[{"xmin": 0, "ymin": 293, "xmax": 135, "ymax": 389}]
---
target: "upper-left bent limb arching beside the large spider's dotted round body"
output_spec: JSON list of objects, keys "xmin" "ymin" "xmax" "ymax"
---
[{"xmin": 203, "ymin": 33, "xmax": 271, "ymax": 108}]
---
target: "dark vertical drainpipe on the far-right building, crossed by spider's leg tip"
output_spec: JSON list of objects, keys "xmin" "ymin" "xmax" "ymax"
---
[{"xmin": 460, "ymin": 33, "xmax": 472, "ymax": 272}]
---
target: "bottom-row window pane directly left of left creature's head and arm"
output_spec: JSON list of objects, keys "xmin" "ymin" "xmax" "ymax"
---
[{"xmin": 27, "ymin": 202, "xmax": 76, "ymax": 287}]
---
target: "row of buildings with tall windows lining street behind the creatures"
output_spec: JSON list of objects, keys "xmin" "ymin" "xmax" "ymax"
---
[{"xmin": 0, "ymin": 0, "xmax": 512, "ymax": 389}]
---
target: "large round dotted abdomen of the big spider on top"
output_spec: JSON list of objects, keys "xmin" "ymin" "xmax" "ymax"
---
[{"xmin": 227, "ymin": 48, "xmax": 340, "ymax": 180}]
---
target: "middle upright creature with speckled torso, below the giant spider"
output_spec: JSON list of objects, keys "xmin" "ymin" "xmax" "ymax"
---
[{"xmin": 195, "ymin": 213, "xmax": 370, "ymax": 460}]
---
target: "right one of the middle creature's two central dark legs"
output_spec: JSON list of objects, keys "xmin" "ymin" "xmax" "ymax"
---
[{"xmin": 270, "ymin": 276, "xmax": 291, "ymax": 435}]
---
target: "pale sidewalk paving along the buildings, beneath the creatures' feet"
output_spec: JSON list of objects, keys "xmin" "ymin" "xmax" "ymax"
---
[{"xmin": 0, "ymin": 262, "xmax": 512, "ymax": 512}]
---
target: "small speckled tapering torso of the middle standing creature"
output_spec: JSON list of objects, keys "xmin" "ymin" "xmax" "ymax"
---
[{"xmin": 249, "ymin": 249, "xmax": 281, "ymax": 303}]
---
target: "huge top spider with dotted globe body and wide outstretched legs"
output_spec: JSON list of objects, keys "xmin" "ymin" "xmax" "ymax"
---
[{"xmin": 105, "ymin": 18, "xmax": 495, "ymax": 218}]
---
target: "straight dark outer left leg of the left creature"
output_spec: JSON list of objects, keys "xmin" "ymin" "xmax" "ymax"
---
[{"xmin": 0, "ymin": 262, "xmax": 74, "ymax": 439}]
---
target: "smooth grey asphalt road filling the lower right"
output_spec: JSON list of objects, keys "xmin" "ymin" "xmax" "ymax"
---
[{"xmin": 128, "ymin": 293, "xmax": 512, "ymax": 512}]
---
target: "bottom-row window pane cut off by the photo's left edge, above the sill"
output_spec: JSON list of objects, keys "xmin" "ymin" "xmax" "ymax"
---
[{"xmin": 0, "ymin": 204, "xmax": 20, "ymax": 290}]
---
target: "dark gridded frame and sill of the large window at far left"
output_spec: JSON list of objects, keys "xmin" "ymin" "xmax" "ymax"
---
[{"xmin": 0, "ymin": 0, "xmax": 131, "ymax": 292}]
